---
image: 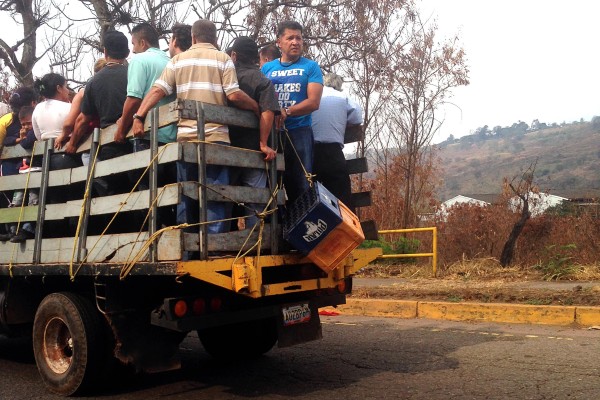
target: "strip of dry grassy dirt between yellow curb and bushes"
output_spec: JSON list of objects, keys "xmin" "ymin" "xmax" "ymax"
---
[{"xmin": 352, "ymin": 261, "xmax": 600, "ymax": 306}]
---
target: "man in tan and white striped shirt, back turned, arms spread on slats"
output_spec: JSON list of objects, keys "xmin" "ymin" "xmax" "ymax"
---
[{"xmin": 133, "ymin": 19, "xmax": 259, "ymax": 250}]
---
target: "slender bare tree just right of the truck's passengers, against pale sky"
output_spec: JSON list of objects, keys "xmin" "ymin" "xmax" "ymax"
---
[{"xmin": 387, "ymin": 15, "xmax": 469, "ymax": 227}]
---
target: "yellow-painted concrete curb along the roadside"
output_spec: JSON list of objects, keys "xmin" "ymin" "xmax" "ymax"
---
[{"xmin": 325, "ymin": 299, "xmax": 600, "ymax": 327}]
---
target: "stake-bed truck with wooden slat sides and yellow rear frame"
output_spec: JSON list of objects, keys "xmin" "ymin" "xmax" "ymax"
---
[{"xmin": 0, "ymin": 101, "xmax": 380, "ymax": 396}]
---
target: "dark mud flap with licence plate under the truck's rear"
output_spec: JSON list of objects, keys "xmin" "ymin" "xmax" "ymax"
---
[{"xmin": 277, "ymin": 301, "xmax": 323, "ymax": 347}]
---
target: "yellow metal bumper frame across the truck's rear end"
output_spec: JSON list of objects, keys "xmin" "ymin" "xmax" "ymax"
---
[{"xmin": 177, "ymin": 248, "xmax": 382, "ymax": 298}]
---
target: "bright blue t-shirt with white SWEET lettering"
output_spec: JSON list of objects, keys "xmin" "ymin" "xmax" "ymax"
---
[{"xmin": 261, "ymin": 57, "xmax": 323, "ymax": 129}]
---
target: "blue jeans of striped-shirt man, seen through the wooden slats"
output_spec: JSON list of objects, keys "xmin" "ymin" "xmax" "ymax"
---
[{"xmin": 177, "ymin": 142, "xmax": 230, "ymax": 233}]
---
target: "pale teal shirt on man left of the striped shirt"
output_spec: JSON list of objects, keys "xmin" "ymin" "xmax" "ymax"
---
[{"xmin": 127, "ymin": 47, "xmax": 177, "ymax": 143}]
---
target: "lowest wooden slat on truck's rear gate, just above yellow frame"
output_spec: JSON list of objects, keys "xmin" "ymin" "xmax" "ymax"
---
[{"xmin": 183, "ymin": 224, "xmax": 271, "ymax": 254}]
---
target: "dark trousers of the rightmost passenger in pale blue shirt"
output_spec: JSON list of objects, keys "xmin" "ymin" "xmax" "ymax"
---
[{"xmin": 313, "ymin": 143, "xmax": 353, "ymax": 209}]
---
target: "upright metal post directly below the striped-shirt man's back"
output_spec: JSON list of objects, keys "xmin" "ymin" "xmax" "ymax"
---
[{"xmin": 196, "ymin": 101, "xmax": 208, "ymax": 260}]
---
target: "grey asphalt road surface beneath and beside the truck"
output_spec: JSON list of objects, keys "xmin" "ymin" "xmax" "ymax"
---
[{"xmin": 0, "ymin": 316, "xmax": 600, "ymax": 400}]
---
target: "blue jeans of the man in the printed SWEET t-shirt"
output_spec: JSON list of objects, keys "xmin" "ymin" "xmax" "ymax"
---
[{"xmin": 282, "ymin": 126, "xmax": 313, "ymax": 203}]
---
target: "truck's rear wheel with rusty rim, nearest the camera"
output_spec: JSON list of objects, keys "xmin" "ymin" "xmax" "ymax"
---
[{"xmin": 33, "ymin": 292, "xmax": 106, "ymax": 396}]
